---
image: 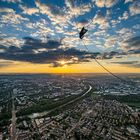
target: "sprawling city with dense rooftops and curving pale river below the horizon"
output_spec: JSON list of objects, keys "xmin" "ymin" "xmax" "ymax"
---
[{"xmin": 0, "ymin": 74, "xmax": 140, "ymax": 140}]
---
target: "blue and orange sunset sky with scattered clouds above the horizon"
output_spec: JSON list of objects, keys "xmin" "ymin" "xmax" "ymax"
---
[{"xmin": 0, "ymin": 0, "xmax": 140, "ymax": 73}]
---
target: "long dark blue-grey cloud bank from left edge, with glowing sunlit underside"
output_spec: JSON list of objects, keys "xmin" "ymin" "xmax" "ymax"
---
[{"xmin": 0, "ymin": 37, "xmax": 121, "ymax": 67}]
